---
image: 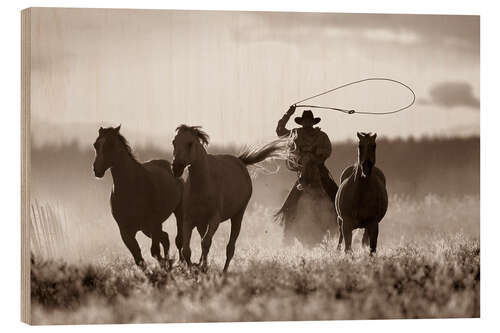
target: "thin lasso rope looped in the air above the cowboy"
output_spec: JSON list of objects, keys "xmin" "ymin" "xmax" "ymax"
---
[{"xmin": 292, "ymin": 77, "xmax": 416, "ymax": 115}]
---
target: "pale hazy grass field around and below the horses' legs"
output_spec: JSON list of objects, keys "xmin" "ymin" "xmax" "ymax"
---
[{"xmin": 31, "ymin": 195, "xmax": 480, "ymax": 324}]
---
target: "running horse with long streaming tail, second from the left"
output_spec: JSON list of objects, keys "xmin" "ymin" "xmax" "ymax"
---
[{"xmin": 173, "ymin": 125, "xmax": 283, "ymax": 271}]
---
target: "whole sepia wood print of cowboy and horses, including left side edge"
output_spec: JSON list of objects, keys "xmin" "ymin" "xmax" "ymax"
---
[{"xmin": 21, "ymin": 8, "xmax": 480, "ymax": 325}]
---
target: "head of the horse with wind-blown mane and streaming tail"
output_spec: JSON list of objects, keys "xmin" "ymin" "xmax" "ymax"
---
[{"xmin": 172, "ymin": 125, "xmax": 209, "ymax": 177}]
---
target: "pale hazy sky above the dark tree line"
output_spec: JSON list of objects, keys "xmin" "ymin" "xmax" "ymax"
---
[{"xmin": 31, "ymin": 9, "xmax": 479, "ymax": 146}]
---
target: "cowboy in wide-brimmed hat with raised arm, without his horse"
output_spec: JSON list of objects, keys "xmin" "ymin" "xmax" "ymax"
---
[{"xmin": 276, "ymin": 105, "xmax": 338, "ymax": 202}]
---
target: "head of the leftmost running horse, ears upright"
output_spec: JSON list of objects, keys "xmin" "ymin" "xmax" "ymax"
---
[{"xmin": 94, "ymin": 125, "xmax": 121, "ymax": 178}]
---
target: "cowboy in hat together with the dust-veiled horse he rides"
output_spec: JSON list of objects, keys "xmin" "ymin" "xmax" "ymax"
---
[{"xmin": 275, "ymin": 105, "xmax": 338, "ymax": 245}]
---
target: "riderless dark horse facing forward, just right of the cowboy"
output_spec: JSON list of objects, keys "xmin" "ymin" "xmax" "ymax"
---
[{"xmin": 335, "ymin": 133, "xmax": 388, "ymax": 254}]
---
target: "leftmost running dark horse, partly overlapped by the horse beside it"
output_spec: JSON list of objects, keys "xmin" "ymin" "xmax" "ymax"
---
[{"xmin": 94, "ymin": 126, "xmax": 183, "ymax": 267}]
